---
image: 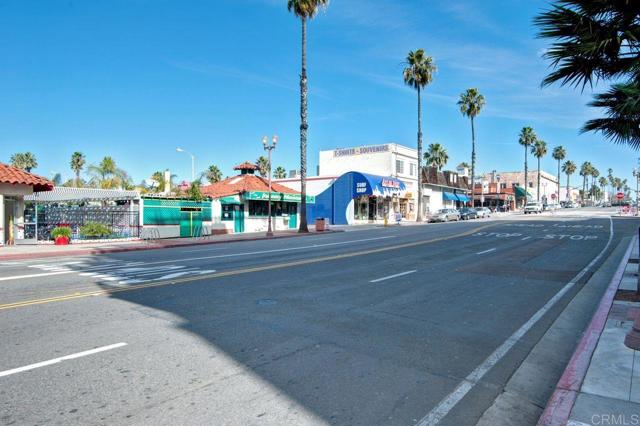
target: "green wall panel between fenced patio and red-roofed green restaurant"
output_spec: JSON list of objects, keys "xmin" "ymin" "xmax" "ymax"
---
[{"xmin": 142, "ymin": 198, "xmax": 212, "ymax": 237}]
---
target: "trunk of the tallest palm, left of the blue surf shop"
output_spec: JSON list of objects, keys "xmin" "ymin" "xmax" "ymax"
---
[{"xmin": 298, "ymin": 18, "xmax": 309, "ymax": 233}]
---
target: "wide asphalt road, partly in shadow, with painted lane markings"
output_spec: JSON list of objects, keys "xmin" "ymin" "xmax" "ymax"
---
[{"xmin": 0, "ymin": 210, "xmax": 638, "ymax": 425}]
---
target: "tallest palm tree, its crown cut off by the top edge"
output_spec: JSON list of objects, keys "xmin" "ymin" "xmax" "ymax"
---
[{"xmin": 287, "ymin": 0, "xmax": 329, "ymax": 232}]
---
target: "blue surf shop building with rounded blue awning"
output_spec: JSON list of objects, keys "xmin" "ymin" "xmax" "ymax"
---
[{"xmin": 307, "ymin": 172, "xmax": 406, "ymax": 225}]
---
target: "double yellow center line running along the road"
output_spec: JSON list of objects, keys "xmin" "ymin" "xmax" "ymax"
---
[{"xmin": 0, "ymin": 224, "xmax": 495, "ymax": 311}]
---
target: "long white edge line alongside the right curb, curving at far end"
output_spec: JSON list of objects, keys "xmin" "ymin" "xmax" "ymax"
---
[{"xmin": 416, "ymin": 218, "xmax": 613, "ymax": 426}]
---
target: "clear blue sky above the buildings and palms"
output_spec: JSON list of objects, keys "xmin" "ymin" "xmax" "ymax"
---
[{"xmin": 0, "ymin": 0, "xmax": 638, "ymax": 186}]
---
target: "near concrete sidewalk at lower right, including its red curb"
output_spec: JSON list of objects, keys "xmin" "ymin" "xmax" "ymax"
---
[{"xmin": 538, "ymin": 237, "xmax": 640, "ymax": 426}]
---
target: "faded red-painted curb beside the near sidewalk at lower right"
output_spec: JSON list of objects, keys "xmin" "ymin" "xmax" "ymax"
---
[{"xmin": 538, "ymin": 237, "xmax": 638, "ymax": 426}]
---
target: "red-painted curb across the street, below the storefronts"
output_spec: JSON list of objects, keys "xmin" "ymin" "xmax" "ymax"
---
[{"xmin": 0, "ymin": 230, "xmax": 345, "ymax": 261}]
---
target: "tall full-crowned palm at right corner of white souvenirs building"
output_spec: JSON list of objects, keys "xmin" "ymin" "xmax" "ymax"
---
[{"xmin": 402, "ymin": 49, "xmax": 436, "ymax": 222}]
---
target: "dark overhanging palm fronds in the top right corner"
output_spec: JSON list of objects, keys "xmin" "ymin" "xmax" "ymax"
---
[{"xmin": 535, "ymin": 0, "xmax": 640, "ymax": 149}]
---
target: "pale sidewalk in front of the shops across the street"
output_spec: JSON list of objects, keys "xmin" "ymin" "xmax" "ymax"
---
[{"xmin": 0, "ymin": 227, "xmax": 342, "ymax": 261}]
